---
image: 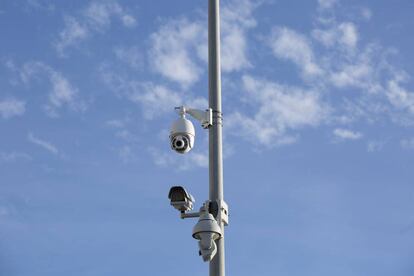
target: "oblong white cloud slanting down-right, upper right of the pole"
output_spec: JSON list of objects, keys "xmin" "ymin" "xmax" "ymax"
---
[{"xmin": 269, "ymin": 27, "xmax": 322, "ymax": 76}]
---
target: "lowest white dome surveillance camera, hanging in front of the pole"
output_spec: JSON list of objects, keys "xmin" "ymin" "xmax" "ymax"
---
[{"xmin": 193, "ymin": 209, "xmax": 222, "ymax": 262}]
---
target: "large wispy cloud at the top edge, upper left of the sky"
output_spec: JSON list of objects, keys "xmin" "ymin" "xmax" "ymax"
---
[{"xmin": 54, "ymin": 0, "xmax": 136, "ymax": 56}]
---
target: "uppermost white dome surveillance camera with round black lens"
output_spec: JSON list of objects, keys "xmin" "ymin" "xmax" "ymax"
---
[{"xmin": 170, "ymin": 116, "xmax": 195, "ymax": 154}]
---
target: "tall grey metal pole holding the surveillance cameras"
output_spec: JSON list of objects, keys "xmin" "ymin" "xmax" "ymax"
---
[{"xmin": 208, "ymin": 0, "xmax": 225, "ymax": 276}]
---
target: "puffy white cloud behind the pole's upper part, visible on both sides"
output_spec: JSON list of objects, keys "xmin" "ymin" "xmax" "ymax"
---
[{"xmin": 149, "ymin": 0, "xmax": 260, "ymax": 88}]
